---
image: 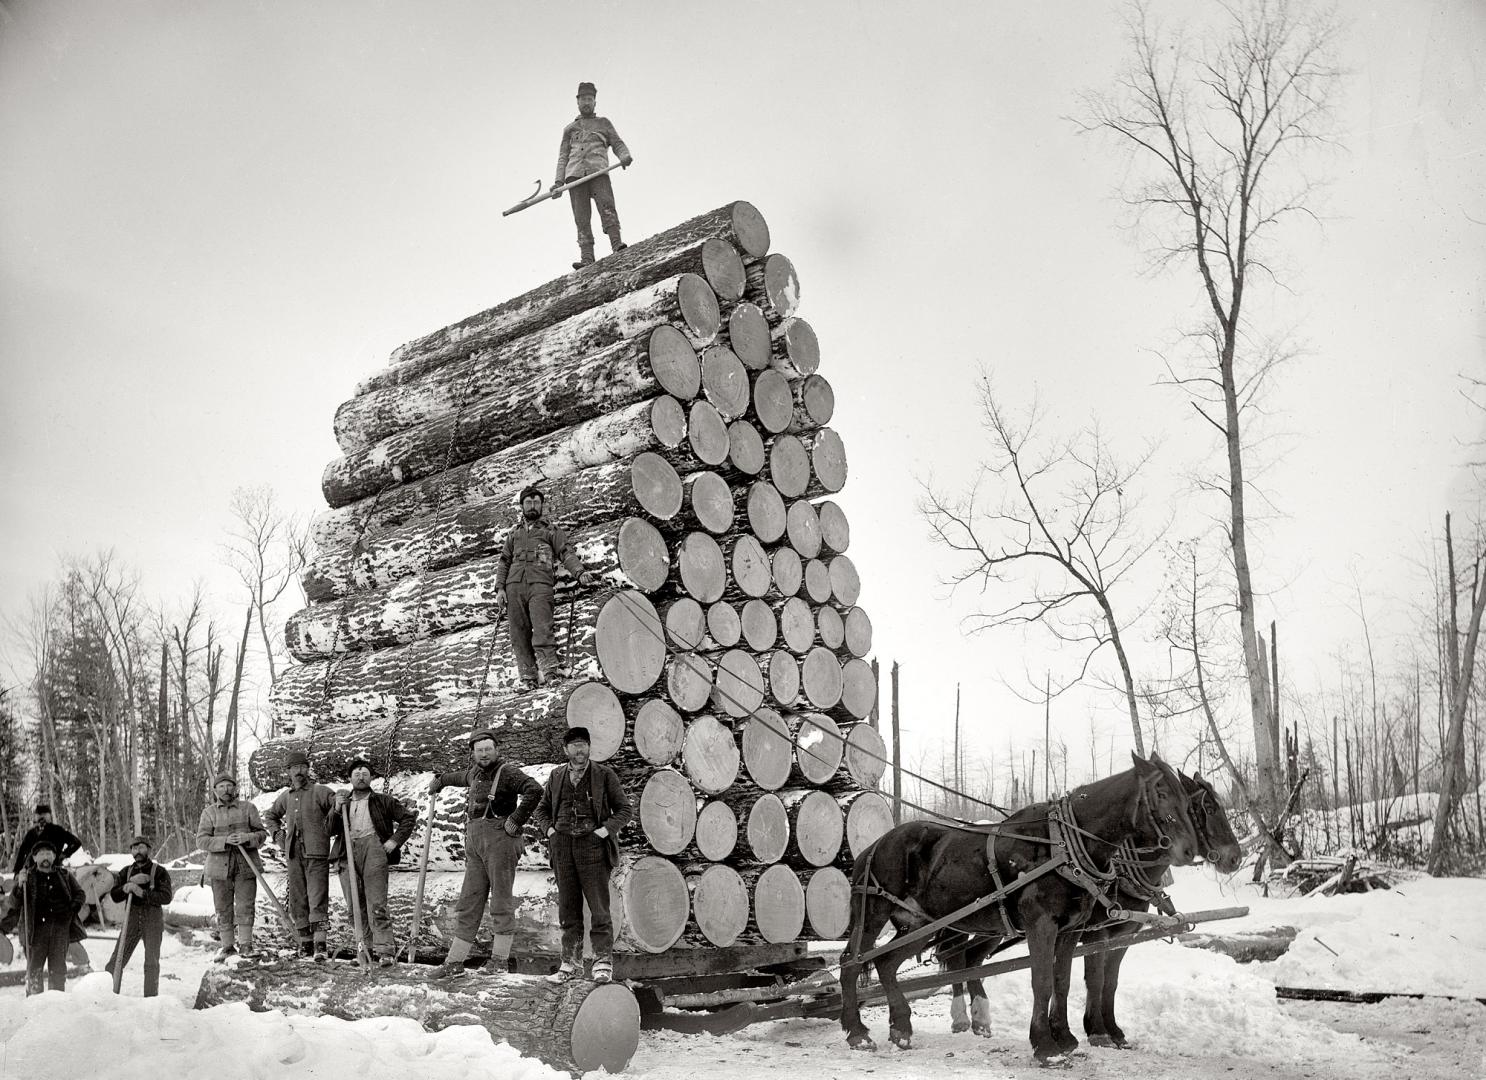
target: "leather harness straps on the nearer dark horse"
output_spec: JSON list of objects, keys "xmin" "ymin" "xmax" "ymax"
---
[{"xmin": 843, "ymin": 780, "xmax": 1177, "ymax": 964}]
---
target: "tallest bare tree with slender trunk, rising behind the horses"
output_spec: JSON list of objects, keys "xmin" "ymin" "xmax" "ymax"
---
[{"xmin": 1079, "ymin": 0, "xmax": 1339, "ymax": 805}]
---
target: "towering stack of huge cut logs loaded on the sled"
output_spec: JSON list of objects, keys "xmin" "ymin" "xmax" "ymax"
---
[{"xmin": 250, "ymin": 202, "xmax": 892, "ymax": 969}]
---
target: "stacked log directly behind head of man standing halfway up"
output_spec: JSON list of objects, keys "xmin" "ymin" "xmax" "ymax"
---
[{"xmin": 310, "ymin": 452, "xmax": 682, "ymax": 602}]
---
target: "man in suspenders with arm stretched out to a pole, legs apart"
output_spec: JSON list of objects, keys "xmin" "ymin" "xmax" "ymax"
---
[{"xmin": 428, "ymin": 731, "xmax": 542, "ymax": 977}]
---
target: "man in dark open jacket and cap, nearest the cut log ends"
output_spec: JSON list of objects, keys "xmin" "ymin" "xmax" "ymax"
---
[{"xmin": 533, "ymin": 728, "xmax": 630, "ymax": 982}]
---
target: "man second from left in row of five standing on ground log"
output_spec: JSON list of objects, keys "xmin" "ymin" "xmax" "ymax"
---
[{"xmin": 263, "ymin": 750, "xmax": 336, "ymax": 960}]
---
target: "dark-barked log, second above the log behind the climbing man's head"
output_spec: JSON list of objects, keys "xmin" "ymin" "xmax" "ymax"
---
[{"xmin": 319, "ymin": 325, "xmax": 701, "ymax": 507}]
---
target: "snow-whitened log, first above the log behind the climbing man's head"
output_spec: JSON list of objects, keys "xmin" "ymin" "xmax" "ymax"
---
[{"xmin": 316, "ymin": 394, "xmax": 691, "ymax": 552}]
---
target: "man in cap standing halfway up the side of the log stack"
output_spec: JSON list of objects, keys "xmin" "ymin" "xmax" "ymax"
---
[{"xmin": 495, "ymin": 486, "xmax": 599, "ymax": 689}]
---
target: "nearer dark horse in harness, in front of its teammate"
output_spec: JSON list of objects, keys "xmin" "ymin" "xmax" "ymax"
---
[{"xmin": 841, "ymin": 753, "xmax": 1199, "ymax": 1061}]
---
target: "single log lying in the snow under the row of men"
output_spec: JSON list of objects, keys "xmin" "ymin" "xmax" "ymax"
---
[{"xmin": 196, "ymin": 961, "xmax": 640, "ymax": 1076}]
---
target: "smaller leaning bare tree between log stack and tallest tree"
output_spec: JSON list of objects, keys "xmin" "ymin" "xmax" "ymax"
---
[{"xmin": 920, "ymin": 374, "xmax": 1155, "ymax": 753}]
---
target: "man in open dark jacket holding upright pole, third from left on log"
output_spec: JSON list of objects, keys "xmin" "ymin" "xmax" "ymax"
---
[{"xmin": 330, "ymin": 758, "xmax": 418, "ymax": 967}]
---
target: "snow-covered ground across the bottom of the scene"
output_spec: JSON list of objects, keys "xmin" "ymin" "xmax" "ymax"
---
[{"xmin": 0, "ymin": 869, "xmax": 1486, "ymax": 1080}]
